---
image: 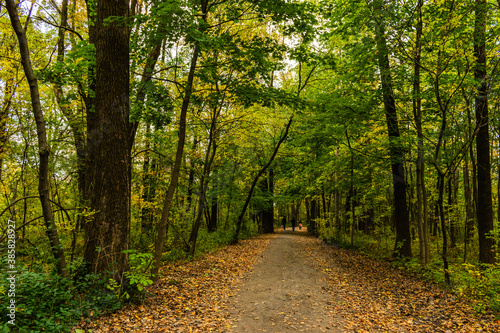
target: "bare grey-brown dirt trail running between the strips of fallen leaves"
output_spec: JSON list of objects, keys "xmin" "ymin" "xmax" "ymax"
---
[{"xmin": 230, "ymin": 228, "xmax": 340, "ymax": 333}]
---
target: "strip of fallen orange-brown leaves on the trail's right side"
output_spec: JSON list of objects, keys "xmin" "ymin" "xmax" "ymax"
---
[{"xmin": 302, "ymin": 235, "xmax": 500, "ymax": 333}]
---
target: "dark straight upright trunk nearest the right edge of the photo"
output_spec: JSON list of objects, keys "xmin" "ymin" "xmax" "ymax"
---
[{"xmin": 474, "ymin": 0, "xmax": 495, "ymax": 264}]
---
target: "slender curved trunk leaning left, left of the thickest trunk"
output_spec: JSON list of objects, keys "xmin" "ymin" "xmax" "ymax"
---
[{"xmin": 6, "ymin": 0, "xmax": 67, "ymax": 276}]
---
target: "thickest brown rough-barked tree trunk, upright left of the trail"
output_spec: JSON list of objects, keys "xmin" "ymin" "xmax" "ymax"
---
[{"xmin": 84, "ymin": 0, "xmax": 131, "ymax": 281}]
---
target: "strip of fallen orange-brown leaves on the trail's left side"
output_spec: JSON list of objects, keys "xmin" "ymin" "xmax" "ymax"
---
[{"xmin": 73, "ymin": 235, "xmax": 273, "ymax": 333}]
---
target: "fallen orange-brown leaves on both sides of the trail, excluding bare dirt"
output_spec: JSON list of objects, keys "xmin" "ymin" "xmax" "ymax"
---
[{"xmin": 73, "ymin": 231, "xmax": 500, "ymax": 333}]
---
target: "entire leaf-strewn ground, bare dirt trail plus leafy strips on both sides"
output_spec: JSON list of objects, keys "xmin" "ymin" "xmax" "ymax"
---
[{"xmin": 74, "ymin": 228, "xmax": 500, "ymax": 333}]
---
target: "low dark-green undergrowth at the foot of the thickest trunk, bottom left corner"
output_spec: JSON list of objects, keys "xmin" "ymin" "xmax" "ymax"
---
[{"xmin": 0, "ymin": 262, "xmax": 121, "ymax": 332}]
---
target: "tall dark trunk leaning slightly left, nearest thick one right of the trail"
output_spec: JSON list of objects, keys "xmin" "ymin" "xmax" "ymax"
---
[{"xmin": 374, "ymin": 0, "xmax": 411, "ymax": 257}]
